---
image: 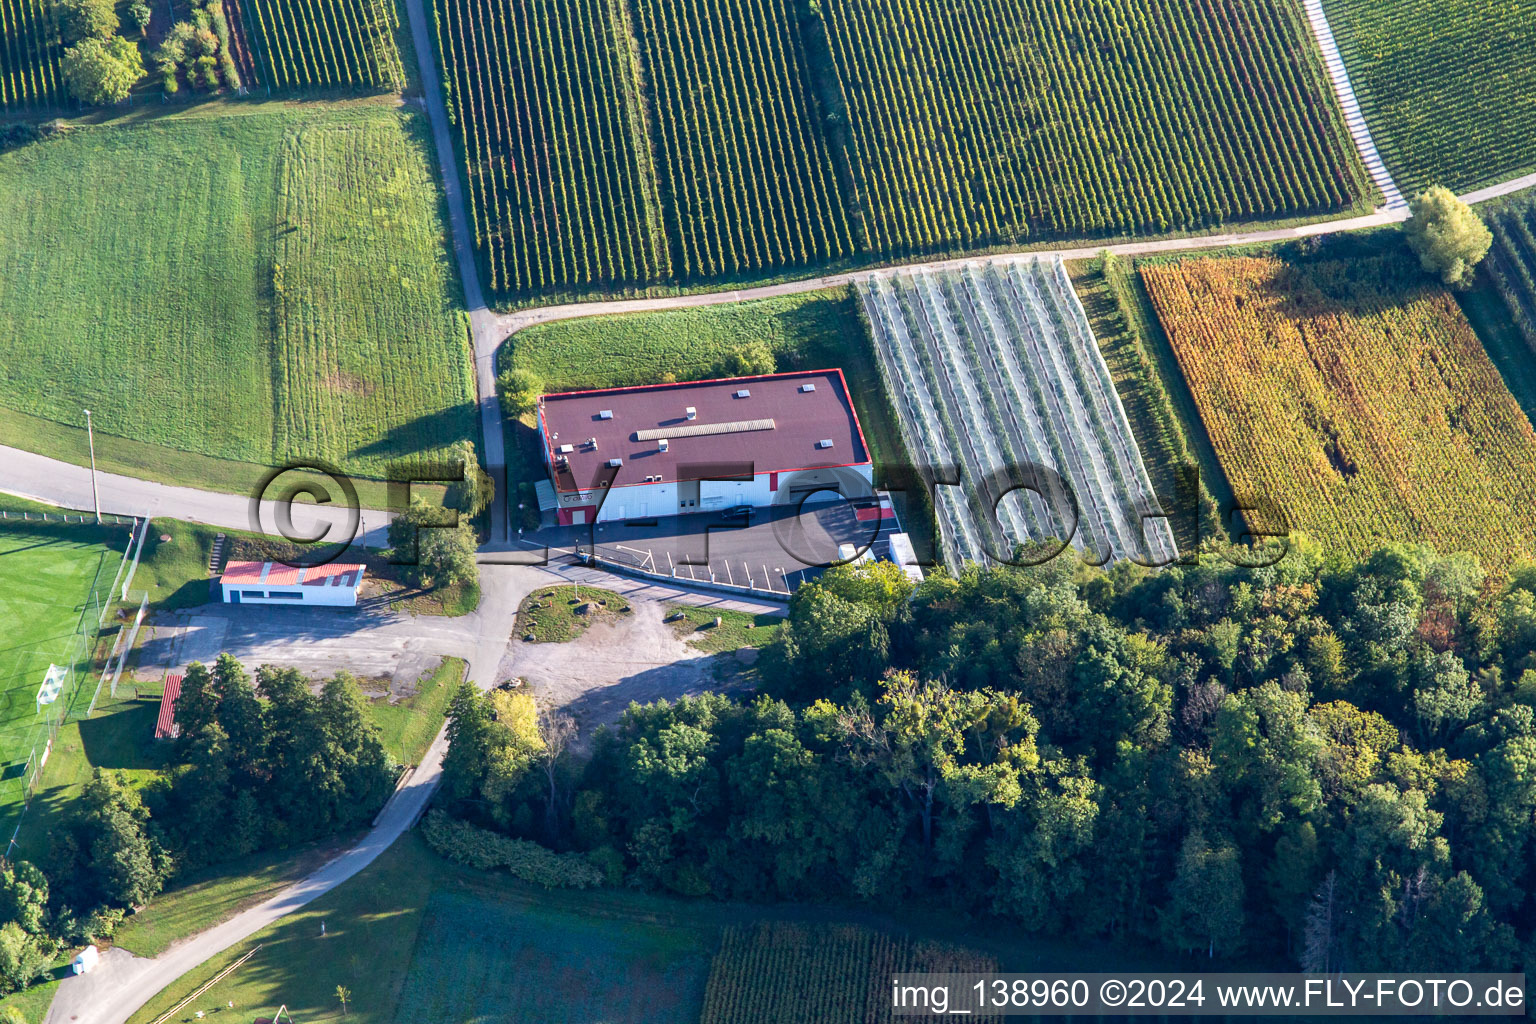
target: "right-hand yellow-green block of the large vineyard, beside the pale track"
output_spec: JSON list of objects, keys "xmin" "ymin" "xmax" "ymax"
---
[{"xmin": 825, "ymin": 0, "xmax": 1367, "ymax": 252}]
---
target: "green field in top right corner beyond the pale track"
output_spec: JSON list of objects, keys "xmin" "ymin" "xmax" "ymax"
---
[{"xmin": 1322, "ymin": 0, "xmax": 1536, "ymax": 193}]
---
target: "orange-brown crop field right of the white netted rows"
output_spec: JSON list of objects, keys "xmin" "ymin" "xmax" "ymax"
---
[{"xmin": 1141, "ymin": 251, "xmax": 1536, "ymax": 570}]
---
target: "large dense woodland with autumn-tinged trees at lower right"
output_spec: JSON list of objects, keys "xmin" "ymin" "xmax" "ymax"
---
[{"xmin": 444, "ymin": 540, "xmax": 1536, "ymax": 970}]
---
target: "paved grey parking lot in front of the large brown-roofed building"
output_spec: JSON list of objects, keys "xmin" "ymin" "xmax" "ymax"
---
[{"xmin": 524, "ymin": 502, "xmax": 895, "ymax": 593}]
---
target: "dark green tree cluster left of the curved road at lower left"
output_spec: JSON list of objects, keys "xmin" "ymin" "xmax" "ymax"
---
[{"xmin": 0, "ymin": 654, "xmax": 395, "ymax": 992}]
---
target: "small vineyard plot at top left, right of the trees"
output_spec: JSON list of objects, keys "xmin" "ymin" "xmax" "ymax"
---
[{"xmin": 241, "ymin": 0, "xmax": 406, "ymax": 92}]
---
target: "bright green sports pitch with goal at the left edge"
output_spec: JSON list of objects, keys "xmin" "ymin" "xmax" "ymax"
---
[{"xmin": 0, "ymin": 520, "xmax": 126, "ymax": 843}]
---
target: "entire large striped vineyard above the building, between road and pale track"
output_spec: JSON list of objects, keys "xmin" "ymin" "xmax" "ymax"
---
[{"xmin": 435, "ymin": 0, "xmax": 1372, "ymax": 298}]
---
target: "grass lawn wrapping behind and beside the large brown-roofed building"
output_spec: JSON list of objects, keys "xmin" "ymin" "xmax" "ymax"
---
[{"xmin": 501, "ymin": 287, "xmax": 934, "ymax": 559}]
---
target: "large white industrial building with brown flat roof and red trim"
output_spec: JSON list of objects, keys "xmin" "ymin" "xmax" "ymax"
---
[{"xmin": 538, "ymin": 370, "xmax": 874, "ymax": 525}]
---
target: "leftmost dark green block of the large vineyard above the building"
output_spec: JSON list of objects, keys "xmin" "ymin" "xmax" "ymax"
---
[{"xmin": 433, "ymin": 0, "xmax": 671, "ymax": 293}]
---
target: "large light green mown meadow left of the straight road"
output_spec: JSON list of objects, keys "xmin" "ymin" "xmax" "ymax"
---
[{"xmin": 0, "ymin": 106, "xmax": 475, "ymax": 490}]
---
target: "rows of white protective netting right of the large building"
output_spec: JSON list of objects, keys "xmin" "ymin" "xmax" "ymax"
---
[{"xmin": 859, "ymin": 258, "xmax": 1178, "ymax": 568}]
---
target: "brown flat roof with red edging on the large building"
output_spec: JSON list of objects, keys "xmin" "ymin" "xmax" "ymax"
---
[{"xmin": 539, "ymin": 370, "xmax": 869, "ymax": 491}]
